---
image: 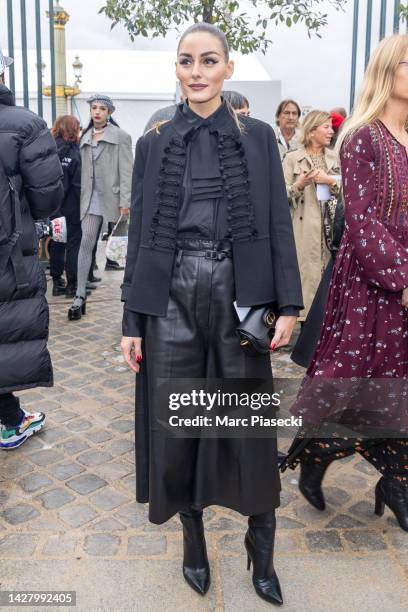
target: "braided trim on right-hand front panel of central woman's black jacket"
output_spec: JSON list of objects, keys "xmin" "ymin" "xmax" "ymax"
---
[{"xmin": 218, "ymin": 134, "xmax": 258, "ymax": 242}]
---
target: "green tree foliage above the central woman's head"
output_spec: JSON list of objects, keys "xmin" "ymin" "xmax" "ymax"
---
[{"xmin": 100, "ymin": 0, "xmax": 347, "ymax": 53}]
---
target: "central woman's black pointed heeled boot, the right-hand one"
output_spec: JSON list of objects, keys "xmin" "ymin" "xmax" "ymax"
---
[{"xmin": 245, "ymin": 511, "xmax": 283, "ymax": 606}]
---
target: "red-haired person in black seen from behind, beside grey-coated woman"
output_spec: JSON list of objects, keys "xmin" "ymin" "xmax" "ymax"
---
[{"xmin": 50, "ymin": 115, "xmax": 82, "ymax": 297}]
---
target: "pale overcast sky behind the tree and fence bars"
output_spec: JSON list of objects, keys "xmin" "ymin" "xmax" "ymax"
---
[{"xmin": 0, "ymin": 0, "xmax": 404, "ymax": 109}]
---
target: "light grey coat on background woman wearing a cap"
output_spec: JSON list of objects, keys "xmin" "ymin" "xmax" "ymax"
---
[{"xmin": 80, "ymin": 123, "xmax": 133, "ymax": 223}]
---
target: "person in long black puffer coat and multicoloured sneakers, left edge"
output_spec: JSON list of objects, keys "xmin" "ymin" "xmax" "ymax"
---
[{"xmin": 0, "ymin": 51, "xmax": 64, "ymax": 449}]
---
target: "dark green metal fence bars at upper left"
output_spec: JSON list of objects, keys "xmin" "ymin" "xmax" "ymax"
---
[{"xmin": 3, "ymin": 0, "xmax": 57, "ymax": 122}]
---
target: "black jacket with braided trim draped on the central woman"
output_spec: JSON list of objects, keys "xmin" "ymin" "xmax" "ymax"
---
[{"xmin": 122, "ymin": 105, "xmax": 303, "ymax": 336}]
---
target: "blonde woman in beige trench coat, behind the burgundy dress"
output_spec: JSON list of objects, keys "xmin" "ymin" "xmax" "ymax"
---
[{"xmin": 283, "ymin": 111, "xmax": 341, "ymax": 321}]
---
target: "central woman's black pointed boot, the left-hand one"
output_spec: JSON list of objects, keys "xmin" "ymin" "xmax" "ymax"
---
[{"xmin": 180, "ymin": 510, "xmax": 210, "ymax": 595}]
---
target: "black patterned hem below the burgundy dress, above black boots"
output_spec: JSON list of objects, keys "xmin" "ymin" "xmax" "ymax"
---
[{"xmin": 299, "ymin": 438, "xmax": 408, "ymax": 486}]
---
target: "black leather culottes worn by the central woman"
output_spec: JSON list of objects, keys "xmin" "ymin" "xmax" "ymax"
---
[{"xmin": 136, "ymin": 240, "xmax": 280, "ymax": 524}]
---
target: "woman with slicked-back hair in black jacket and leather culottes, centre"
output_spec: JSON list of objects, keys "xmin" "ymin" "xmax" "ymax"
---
[{"xmin": 122, "ymin": 24, "xmax": 302, "ymax": 603}]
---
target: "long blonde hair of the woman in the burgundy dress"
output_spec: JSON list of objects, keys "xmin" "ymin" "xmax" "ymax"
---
[{"xmin": 336, "ymin": 34, "xmax": 408, "ymax": 151}]
